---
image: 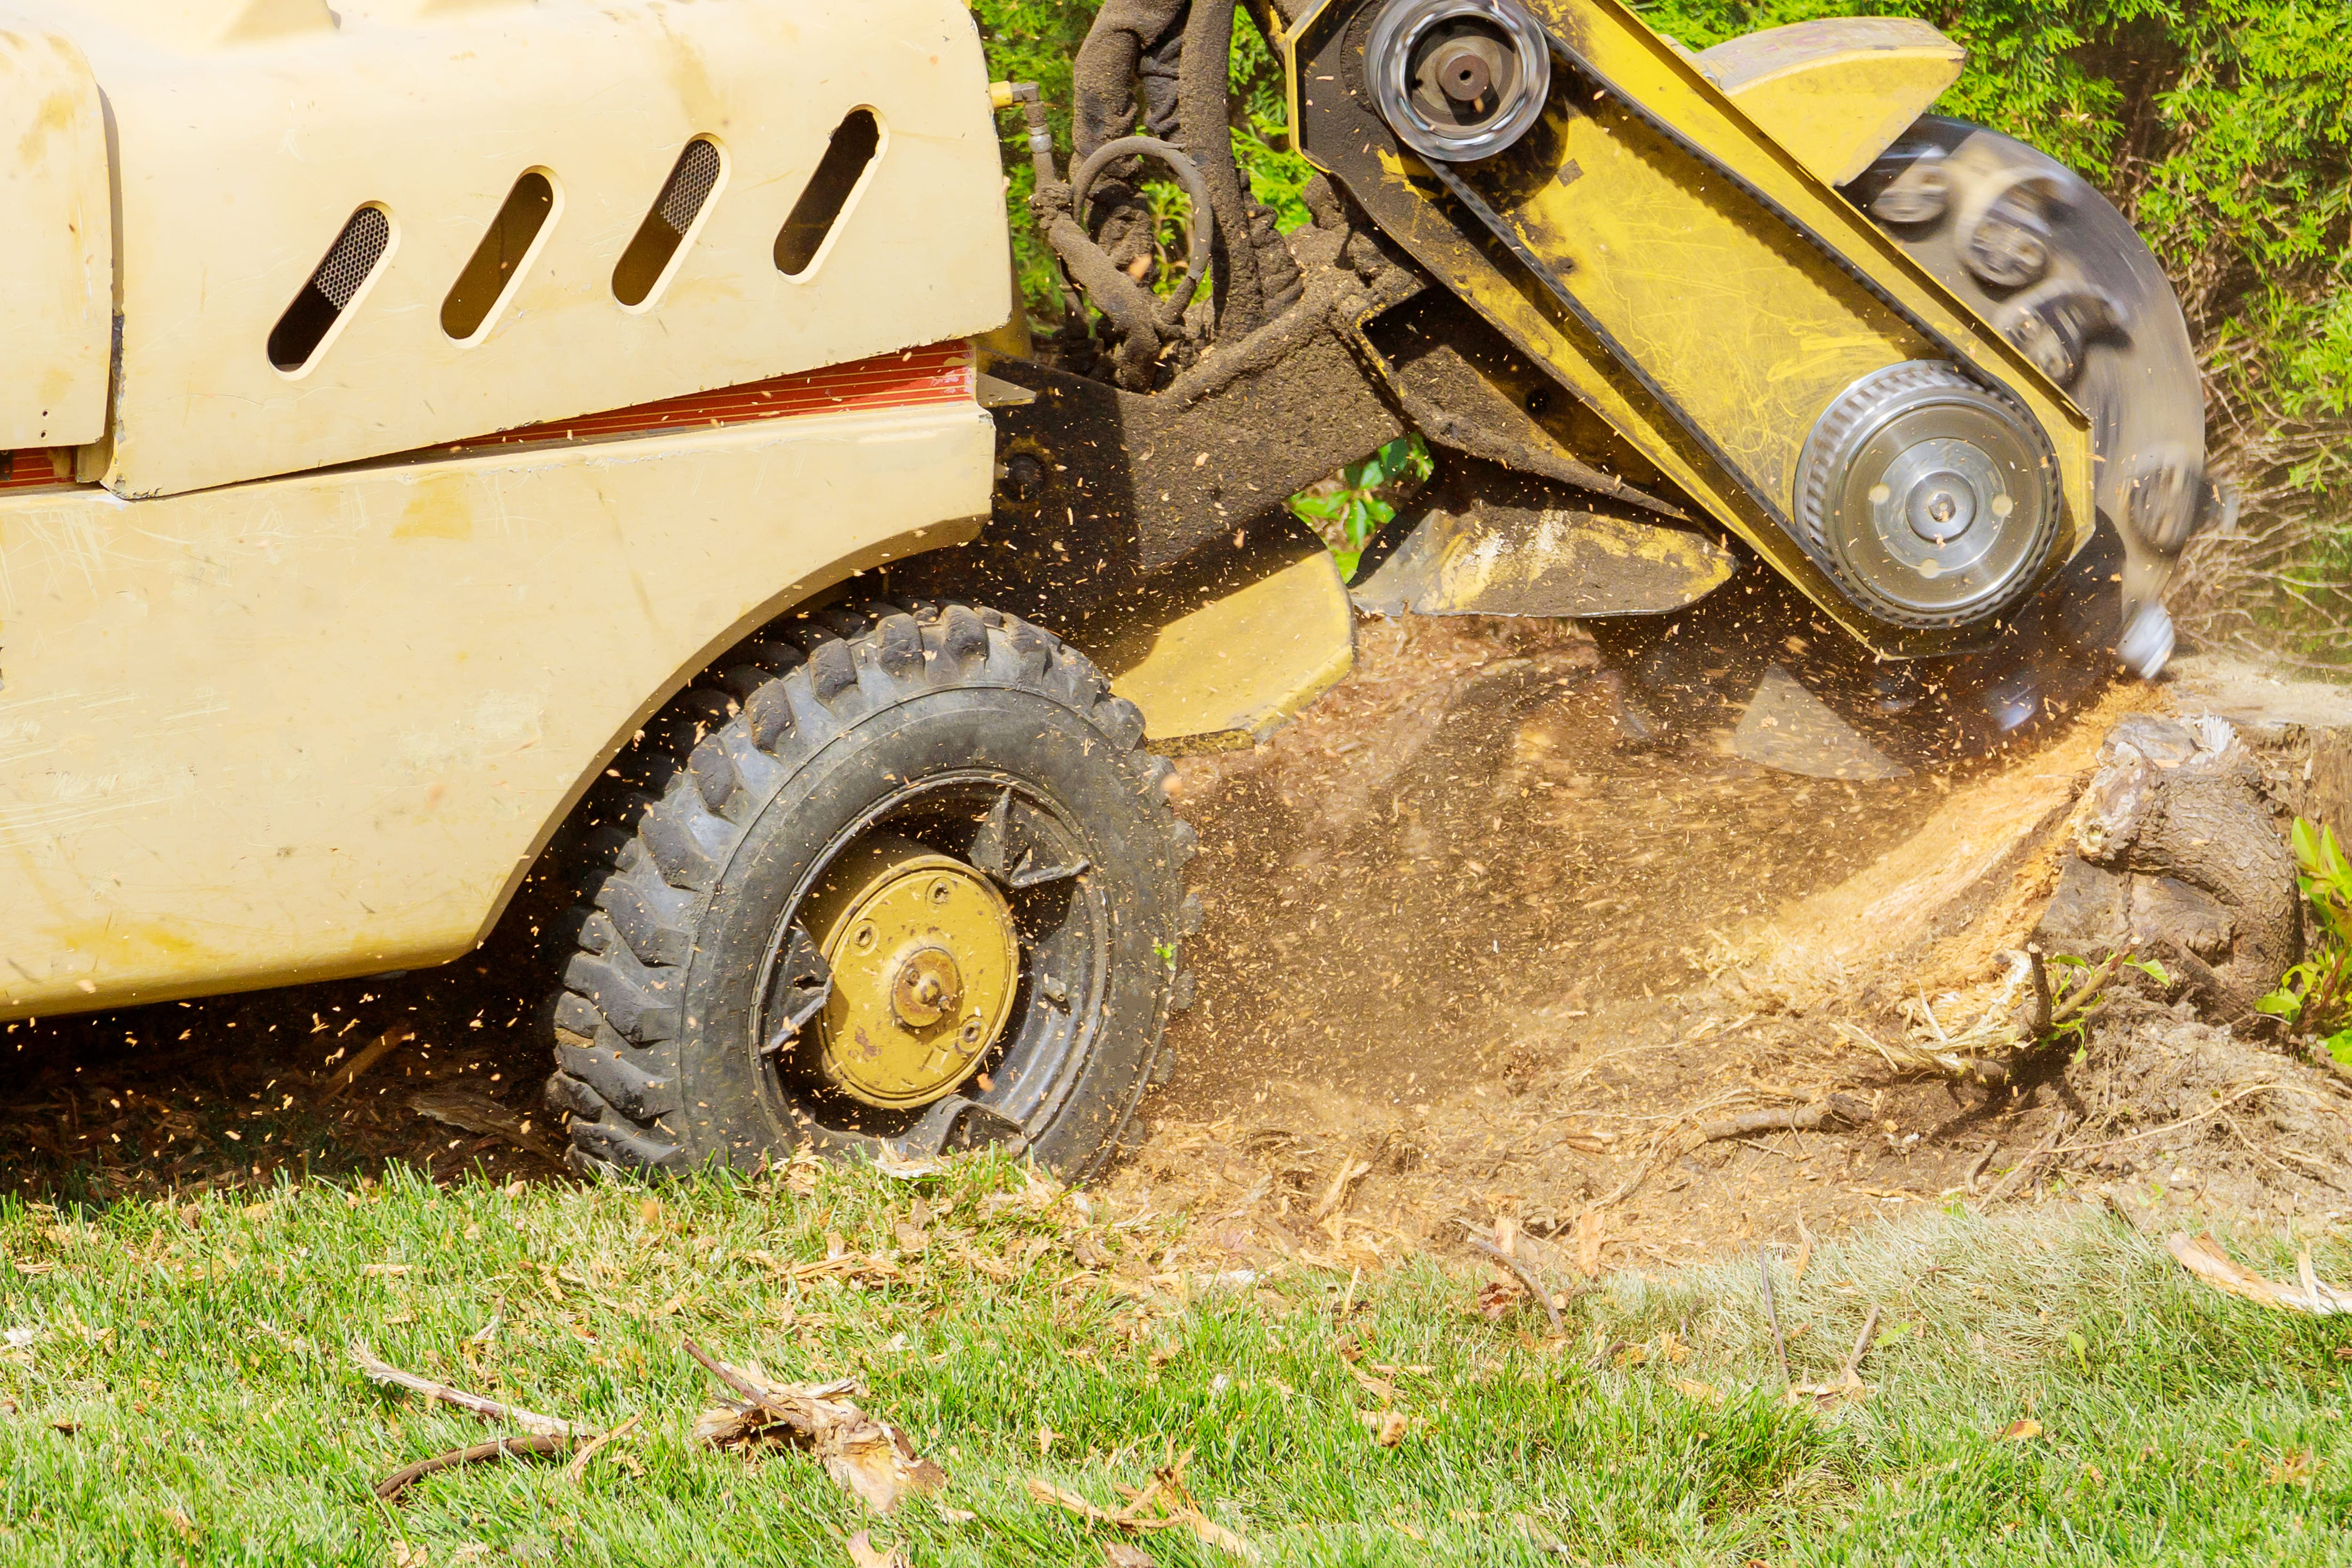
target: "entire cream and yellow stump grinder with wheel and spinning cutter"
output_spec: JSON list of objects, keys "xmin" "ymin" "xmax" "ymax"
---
[{"xmin": 0, "ymin": 0, "xmax": 2230, "ymax": 1176}]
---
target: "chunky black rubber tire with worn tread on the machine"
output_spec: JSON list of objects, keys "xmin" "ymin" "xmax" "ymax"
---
[{"xmin": 548, "ymin": 604, "xmax": 1200, "ymax": 1180}]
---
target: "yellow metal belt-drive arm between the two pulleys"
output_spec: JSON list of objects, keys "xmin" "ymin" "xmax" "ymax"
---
[{"xmin": 1284, "ymin": 0, "xmax": 2093, "ymax": 656}]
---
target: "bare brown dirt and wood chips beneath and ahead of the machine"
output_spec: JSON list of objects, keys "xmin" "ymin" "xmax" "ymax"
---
[{"xmin": 0, "ymin": 621, "xmax": 2352, "ymax": 1272}]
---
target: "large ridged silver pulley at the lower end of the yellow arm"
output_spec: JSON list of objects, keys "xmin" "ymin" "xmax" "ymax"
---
[{"xmin": 1797, "ymin": 360, "xmax": 2058, "ymax": 628}]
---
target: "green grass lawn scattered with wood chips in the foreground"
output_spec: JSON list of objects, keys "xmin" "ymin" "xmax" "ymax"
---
[{"xmin": 0, "ymin": 1162, "xmax": 2352, "ymax": 1568}]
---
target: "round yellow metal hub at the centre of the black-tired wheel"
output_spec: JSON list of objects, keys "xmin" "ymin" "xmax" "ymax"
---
[{"xmin": 802, "ymin": 837, "xmax": 1021, "ymax": 1110}]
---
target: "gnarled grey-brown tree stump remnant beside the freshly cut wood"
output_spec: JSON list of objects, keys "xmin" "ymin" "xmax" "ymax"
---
[{"xmin": 2034, "ymin": 715, "xmax": 2303, "ymax": 1020}]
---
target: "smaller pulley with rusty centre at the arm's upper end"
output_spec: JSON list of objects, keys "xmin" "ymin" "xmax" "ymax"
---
[{"xmin": 1364, "ymin": 0, "xmax": 1552, "ymax": 162}]
